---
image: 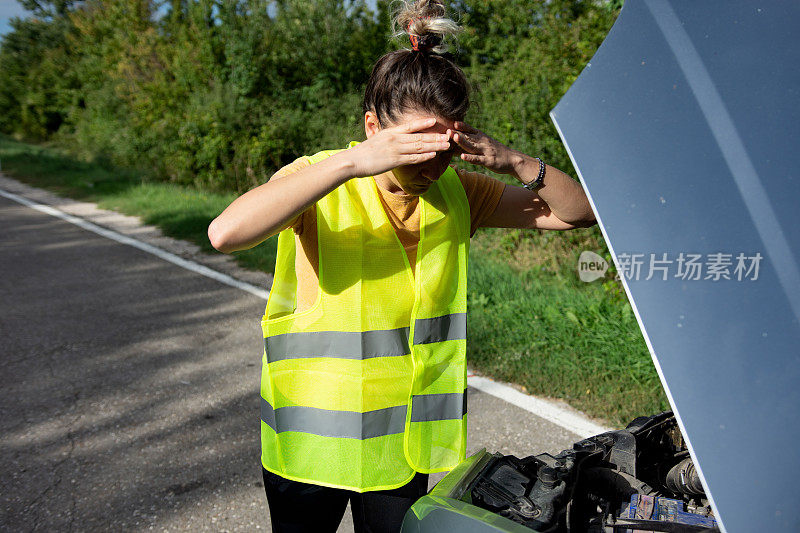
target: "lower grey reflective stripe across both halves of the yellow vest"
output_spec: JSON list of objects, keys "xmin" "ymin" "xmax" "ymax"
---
[{"xmin": 261, "ymin": 391, "xmax": 467, "ymax": 439}]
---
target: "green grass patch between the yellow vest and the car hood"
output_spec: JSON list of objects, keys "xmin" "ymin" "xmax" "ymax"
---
[{"xmin": 467, "ymin": 254, "xmax": 668, "ymax": 425}]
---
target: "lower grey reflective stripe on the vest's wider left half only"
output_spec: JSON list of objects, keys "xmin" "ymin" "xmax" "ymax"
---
[{"xmin": 261, "ymin": 398, "xmax": 406, "ymax": 439}]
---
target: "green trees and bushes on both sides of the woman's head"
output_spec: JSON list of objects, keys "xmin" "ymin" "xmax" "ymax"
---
[{"xmin": 0, "ymin": 0, "xmax": 618, "ymax": 192}]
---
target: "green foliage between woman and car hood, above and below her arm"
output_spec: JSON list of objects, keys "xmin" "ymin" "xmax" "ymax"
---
[{"xmin": 450, "ymin": 0, "xmax": 625, "ymax": 316}]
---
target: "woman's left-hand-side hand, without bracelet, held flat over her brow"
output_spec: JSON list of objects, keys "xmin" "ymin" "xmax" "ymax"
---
[{"xmin": 341, "ymin": 118, "xmax": 450, "ymax": 177}]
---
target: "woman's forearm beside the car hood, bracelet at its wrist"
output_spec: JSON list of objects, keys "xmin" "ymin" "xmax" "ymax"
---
[{"xmin": 512, "ymin": 153, "xmax": 595, "ymax": 226}]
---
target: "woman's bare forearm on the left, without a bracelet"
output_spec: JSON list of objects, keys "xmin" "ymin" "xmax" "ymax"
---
[{"xmin": 208, "ymin": 153, "xmax": 353, "ymax": 253}]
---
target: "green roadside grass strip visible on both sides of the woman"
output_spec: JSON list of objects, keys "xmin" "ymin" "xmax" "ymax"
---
[{"xmin": 0, "ymin": 135, "xmax": 668, "ymax": 425}]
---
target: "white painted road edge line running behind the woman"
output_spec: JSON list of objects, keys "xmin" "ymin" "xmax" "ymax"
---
[{"xmin": 0, "ymin": 185, "xmax": 609, "ymax": 437}]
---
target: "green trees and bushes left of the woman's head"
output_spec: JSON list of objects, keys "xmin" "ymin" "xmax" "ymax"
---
[{"xmin": 0, "ymin": 0, "xmax": 387, "ymax": 192}]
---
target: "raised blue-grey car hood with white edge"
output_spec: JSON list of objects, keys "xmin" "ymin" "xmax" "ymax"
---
[{"xmin": 551, "ymin": 0, "xmax": 800, "ymax": 531}]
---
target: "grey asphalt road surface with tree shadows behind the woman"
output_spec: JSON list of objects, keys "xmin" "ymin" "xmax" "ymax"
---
[{"xmin": 0, "ymin": 197, "xmax": 577, "ymax": 532}]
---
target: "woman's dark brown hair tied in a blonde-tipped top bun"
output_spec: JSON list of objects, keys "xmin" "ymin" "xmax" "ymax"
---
[{"xmin": 362, "ymin": 0, "xmax": 470, "ymax": 125}]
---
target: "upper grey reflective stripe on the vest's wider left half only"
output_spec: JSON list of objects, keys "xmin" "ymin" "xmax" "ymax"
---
[{"xmin": 264, "ymin": 328, "xmax": 410, "ymax": 363}]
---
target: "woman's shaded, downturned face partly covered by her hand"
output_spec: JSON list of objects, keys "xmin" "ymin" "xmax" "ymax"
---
[{"xmin": 368, "ymin": 111, "xmax": 458, "ymax": 196}]
